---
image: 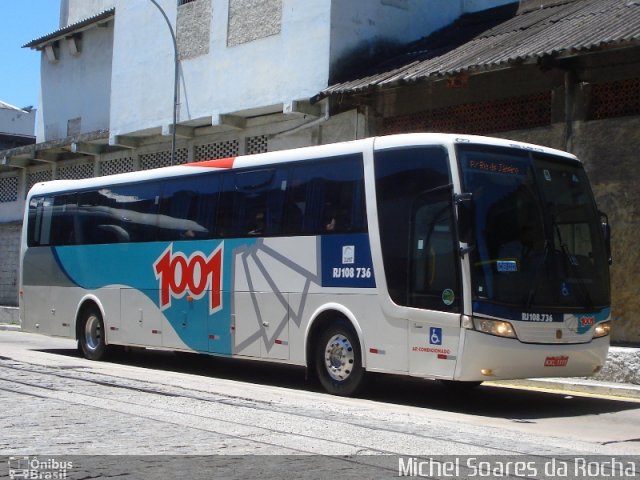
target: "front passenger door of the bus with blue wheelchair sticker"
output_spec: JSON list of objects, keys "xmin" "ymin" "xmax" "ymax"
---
[{"xmin": 407, "ymin": 186, "xmax": 462, "ymax": 377}]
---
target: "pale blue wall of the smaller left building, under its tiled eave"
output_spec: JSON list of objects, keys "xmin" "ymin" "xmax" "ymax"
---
[{"xmin": 36, "ymin": 22, "xmax": 113, "ymax": 143}]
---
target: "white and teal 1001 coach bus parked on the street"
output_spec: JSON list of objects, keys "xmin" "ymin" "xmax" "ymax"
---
[{"xmin": 20, "ymin": 133, "xmax": 611, "ymax": 395}]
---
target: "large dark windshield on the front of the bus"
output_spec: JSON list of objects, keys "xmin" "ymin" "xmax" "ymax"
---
[{"xmin": 458, "ymin": 145, "xmax": 610, "ymax": 313}]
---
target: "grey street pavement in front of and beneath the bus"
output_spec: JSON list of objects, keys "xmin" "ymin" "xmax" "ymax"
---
[{"xmin": 0, "ymin": 331, "xmax": 640, "ymax": 478}]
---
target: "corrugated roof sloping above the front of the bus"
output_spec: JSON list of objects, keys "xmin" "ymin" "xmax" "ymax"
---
[{"xmin": 320, "ymin": 0, "xmax": 640, "ymax": 96}]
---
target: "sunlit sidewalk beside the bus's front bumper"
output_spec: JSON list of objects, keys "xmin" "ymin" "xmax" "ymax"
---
[{"xmin": 0, "ymin": 323, "xmax": 640, "ymax": 400}]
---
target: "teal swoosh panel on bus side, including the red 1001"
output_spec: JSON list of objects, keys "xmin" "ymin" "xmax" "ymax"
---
[{"xmin": 54, "ymin": 239, "xmax": 256, "ymax": 355}]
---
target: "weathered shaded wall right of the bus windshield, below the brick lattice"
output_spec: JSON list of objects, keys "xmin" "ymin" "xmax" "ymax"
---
[{"xmin": 484, "ymin": 117, "xmax": 640, "ymax": 345}]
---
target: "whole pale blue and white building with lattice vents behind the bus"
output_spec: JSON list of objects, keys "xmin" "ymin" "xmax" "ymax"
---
[{"xmin": 0, "ymin": 0, "xmax": 514, "ymax": 312}]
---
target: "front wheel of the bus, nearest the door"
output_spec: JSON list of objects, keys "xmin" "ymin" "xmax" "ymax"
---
[{"xmin": 315, "ymin": 321, "xmax": 364, "ymax": 396}]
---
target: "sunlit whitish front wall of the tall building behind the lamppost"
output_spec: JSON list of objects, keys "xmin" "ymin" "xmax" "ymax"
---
[{"xmin": 111, "ymin": 0, "xmax": 330, "ymax": 135}]
